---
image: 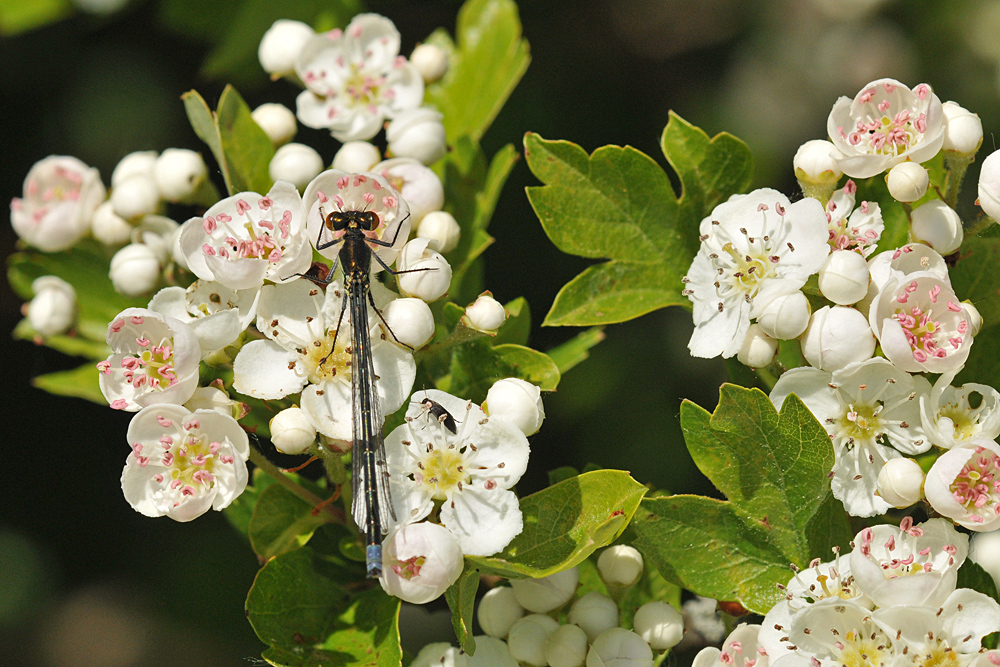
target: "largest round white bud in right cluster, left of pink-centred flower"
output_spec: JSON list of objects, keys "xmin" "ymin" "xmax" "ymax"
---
[{"xmin": 801, "ymin": 306, "xmax": 875, "ymax": 373}]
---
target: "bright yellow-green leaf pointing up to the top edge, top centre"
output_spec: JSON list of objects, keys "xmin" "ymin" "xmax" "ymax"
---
[{"xmin": 424, "ymin": 0, "xmax": 531, "ymax": 145}]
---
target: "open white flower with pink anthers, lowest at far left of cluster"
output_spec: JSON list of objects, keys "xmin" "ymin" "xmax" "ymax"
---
[{"xmin": 122, "ymin": 404, "xmax": 250, "ymax": 521}]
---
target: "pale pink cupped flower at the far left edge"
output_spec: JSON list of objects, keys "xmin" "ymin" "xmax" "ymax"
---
[{"xmin": 10, "ymin": 155, "xmax": 107, "ymax": 252}]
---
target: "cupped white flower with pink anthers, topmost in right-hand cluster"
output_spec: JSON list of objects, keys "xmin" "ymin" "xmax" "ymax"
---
[{"xmin": 826, "ymin": 79, "xmax": 944, "ymax": 178}]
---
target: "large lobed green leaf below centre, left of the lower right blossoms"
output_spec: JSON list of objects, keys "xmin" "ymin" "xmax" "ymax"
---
[{"xmin": 633, "ymin": 384, "xmax": 853, "ymax": 613}]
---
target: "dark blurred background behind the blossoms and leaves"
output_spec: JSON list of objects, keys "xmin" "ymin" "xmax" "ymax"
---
[{"xmin": 0, "ymin": 0, "xmax": 1000, "ymax": 667}]
